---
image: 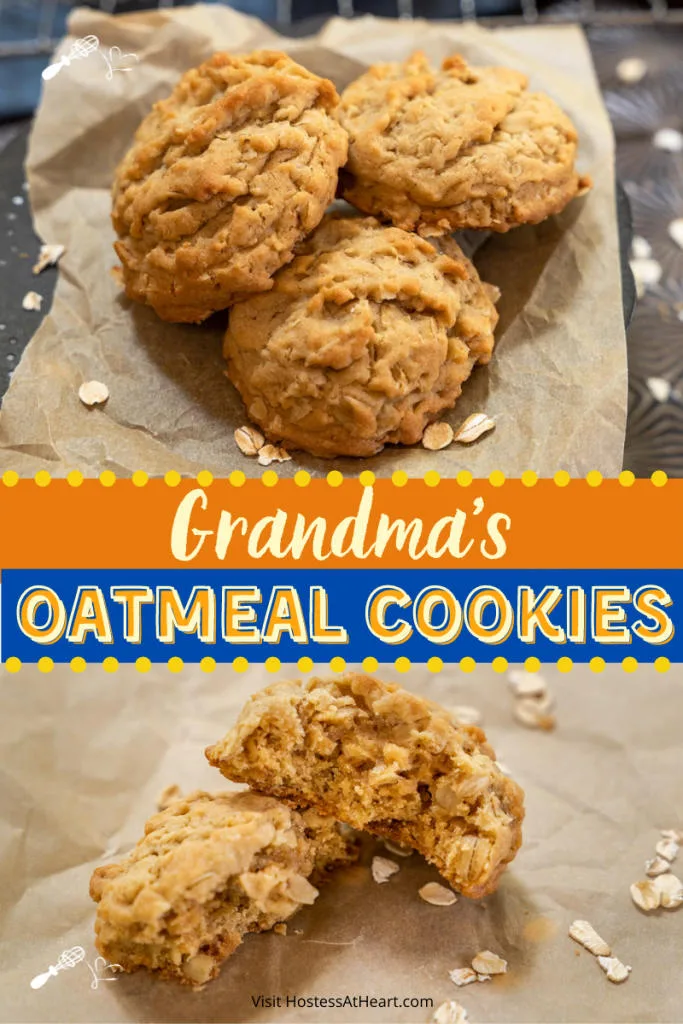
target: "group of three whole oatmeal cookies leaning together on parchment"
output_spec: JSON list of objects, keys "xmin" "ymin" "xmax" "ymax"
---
[{"xmin": 113, "ymin": 51, "xmax": 589, "ymax": 457}]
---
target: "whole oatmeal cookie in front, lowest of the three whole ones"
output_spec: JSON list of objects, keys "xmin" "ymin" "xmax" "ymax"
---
[{"xmin": 224, "ymin": 215, "xmax": 498, "ymax": 458}]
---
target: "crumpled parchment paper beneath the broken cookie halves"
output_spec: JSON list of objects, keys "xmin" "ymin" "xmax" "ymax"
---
[{"xmin": 0, "ymin": 667, "xmax": 683, "ymax": 1024}]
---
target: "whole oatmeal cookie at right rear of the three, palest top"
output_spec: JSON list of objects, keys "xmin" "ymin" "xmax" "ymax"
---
[{"xmin": 339, "ymin": 52, "xmax": 590, "ymax": 234}]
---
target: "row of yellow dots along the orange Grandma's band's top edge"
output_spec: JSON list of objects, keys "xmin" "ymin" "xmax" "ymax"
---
[{"xmin": 0, "ymin": 469, "xmax": 670, "ymax": 489}]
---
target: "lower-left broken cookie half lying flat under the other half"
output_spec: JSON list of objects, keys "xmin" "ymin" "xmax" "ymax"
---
[{"xmin": 90, "ymin": 792, "xmax": 355, "ymax": 986}]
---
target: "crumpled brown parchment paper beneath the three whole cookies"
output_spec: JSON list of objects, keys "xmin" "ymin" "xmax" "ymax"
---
[{"xmin": 0, "ymin": 5, "xmax": 626, "ymax": 476}]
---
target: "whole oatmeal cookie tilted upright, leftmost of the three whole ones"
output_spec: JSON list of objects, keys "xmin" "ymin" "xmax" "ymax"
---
[{"xmin": 112, "ymin": 50, "xmax": 347, "ymax": 323}]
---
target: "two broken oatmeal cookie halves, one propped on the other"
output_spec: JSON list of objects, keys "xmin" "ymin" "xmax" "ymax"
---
[{"xmin": 90, "ymin": 674, "xmax": 524, "ymax": 987}]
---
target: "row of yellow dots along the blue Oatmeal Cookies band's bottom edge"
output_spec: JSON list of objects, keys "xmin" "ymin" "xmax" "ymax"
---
[{"xmin": 2, "ymin": 655, "xmax": 672, "ymax": 675}]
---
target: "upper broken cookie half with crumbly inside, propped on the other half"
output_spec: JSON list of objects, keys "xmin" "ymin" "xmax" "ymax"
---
[{"xmin": 207, "ymin": 673, "xmax": 524, "ymax": 898}]
